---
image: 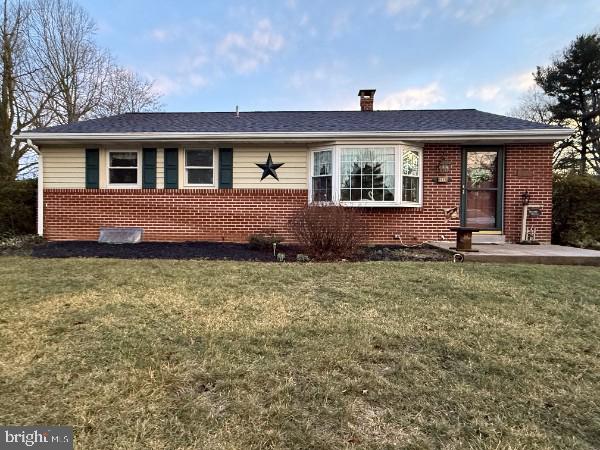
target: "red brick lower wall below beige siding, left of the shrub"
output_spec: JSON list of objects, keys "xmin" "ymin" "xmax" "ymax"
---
[{"xmin": 44, "ymin": 189, "xmax": 307, "ymax": 241}]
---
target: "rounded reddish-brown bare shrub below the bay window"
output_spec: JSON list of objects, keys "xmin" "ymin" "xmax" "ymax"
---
[{"xmin": 291, "ymin": 204, "xmax": 365, "ymax": 260}]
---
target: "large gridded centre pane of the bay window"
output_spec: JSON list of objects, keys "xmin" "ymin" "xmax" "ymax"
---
[{"xmin": 340, "ymin": 147, "xmax": 396, "ymax": 202}]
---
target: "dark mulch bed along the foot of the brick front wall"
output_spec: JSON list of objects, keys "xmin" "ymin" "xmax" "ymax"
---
[{"xmin": 31, "ymin": 241, "xmax": 451, "ymax": 261}]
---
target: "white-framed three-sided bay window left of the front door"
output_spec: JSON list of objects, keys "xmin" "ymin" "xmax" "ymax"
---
[{"xmin": 309, "ymin": 145, "xmax": 422, "ymax": 206}]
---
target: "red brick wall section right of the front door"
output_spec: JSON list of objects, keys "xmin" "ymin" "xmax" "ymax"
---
[{"xmin": 504, "ymin": 144, "xmax": 553, "ymax": 242}]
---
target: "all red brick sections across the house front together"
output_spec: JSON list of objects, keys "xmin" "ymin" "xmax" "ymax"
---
[{"xmin": 44, "ymin": 144, "xmax": 552, "ymax": 244}]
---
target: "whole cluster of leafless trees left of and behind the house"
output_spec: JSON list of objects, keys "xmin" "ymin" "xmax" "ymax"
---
[{"xmin": 0, "ymin": 0, "xmax": 161, "ymax": 181}]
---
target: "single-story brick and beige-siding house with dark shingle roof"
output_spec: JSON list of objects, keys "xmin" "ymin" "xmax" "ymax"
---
[{"xmin": 17, "ymin": 90, "xmax": 571, "ymax": 244}]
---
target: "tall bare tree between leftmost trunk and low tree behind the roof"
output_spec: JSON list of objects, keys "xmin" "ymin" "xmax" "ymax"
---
[{"xmin": 31, "ymin": 0, "xmax": 110, "ymax": 123}]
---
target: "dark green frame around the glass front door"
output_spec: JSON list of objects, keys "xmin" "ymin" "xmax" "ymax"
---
[{"xmin": 460, "ymin": 145, "xmax": 506, "ymax": 232}]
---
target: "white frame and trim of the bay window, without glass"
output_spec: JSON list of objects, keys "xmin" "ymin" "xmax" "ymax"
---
[{"xmin": 307, "ymin": 142, "xmax": 423, "ymax": 208}]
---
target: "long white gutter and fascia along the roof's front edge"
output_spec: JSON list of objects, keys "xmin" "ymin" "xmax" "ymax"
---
[{"xmin": 15, "ymin": 128, "xmax": 575, "ymax": 142}]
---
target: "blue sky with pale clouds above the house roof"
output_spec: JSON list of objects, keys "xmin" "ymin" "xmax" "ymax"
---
[{"xmin": 79, "ymin": 0, "xmax": 600, "ymax": 114}]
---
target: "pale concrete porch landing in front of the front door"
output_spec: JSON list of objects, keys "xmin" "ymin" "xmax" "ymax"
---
[{"xmin": 429, "ymin": 241, "xmax": 600, "ymax": 266}]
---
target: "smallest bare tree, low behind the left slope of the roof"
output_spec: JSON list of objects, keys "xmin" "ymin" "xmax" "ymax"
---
[{"xmin": 93, "ymin": 66, "xmax": 162, "ymax": 117}]
